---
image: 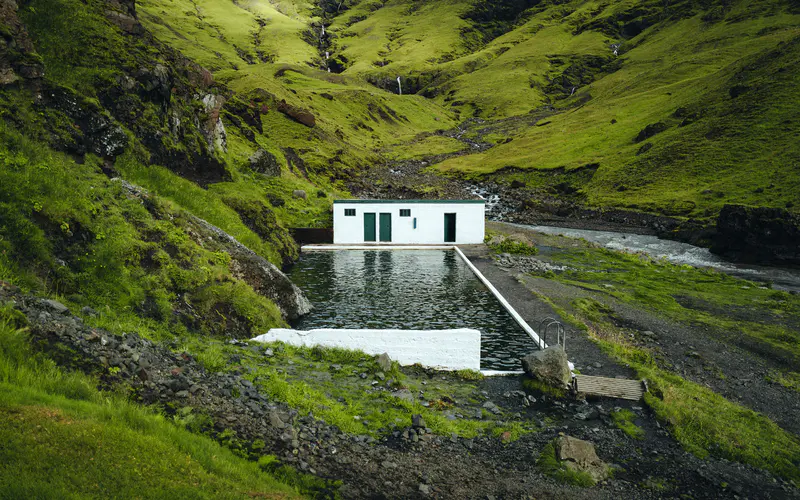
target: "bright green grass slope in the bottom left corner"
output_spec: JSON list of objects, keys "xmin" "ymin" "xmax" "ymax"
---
[{"xmin": 0, "ymin": 309, "xmax": 299, "ymax": 498}]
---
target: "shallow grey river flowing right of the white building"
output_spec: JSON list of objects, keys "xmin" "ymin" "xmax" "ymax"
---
[{"xmin": 512, "ymin": 224, "xmax": 800, "ymax": 291}]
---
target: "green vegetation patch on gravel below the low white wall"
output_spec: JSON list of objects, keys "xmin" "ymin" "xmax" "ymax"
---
[{"xmin": 181, "ymin": 338, "xmax": 536, "ymax": 441}]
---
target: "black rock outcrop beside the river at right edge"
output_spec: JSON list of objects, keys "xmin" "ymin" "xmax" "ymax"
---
[{"xmin": 711, "ymin": 205, "xmax": 800, "ymax": 264}]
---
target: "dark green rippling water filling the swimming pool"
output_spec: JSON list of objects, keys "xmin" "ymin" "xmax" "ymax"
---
[{"xmin": 289, "ymin": 250, "xmax": 536, "ymax": 370}]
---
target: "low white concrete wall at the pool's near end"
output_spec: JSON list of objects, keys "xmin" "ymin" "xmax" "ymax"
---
[{"xmin": 253, "ymin": 328, "xmax": 481, "ymax": 370}]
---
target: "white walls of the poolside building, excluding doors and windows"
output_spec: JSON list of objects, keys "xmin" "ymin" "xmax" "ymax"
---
[{"xmin": 333, "ymin": 200, "xmax": 485, "ymax": 245}]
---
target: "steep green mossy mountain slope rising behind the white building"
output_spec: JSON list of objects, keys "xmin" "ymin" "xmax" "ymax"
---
[{"xmin": 134, "ymin": 0, "xmax": 800, "ymax": 230}]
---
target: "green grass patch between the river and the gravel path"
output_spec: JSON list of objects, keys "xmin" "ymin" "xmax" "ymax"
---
[{"xmin": 553, "ymin": 247, "xmax": 800, "ymax": 363}]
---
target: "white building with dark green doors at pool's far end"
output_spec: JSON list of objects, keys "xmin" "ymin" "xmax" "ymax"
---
[{"xmin": 333, "ymin": 200, "xmax": 485, "ymax": 245}]
